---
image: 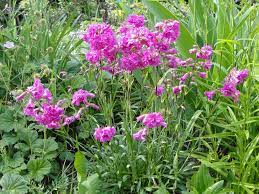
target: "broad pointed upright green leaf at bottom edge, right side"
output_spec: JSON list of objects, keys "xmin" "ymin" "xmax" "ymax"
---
[{"xmin": 190, "ymin": 164, "xmax": 214, "ymax": 193}]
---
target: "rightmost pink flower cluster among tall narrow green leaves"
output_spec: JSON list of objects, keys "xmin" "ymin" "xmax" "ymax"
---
[{"xmin": 204, "ymin": 68, "xmax": 248, "ymax": 102}]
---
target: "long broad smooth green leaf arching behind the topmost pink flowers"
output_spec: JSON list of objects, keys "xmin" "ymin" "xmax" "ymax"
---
[{"xmin": 143, "ymin": 0, "xmax": 195, "ymax": 58}]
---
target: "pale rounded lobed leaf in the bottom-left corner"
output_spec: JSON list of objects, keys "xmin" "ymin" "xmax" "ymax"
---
[{"xmin": 0, "ymin": 174, "xmax": 28, "ymax": 194}]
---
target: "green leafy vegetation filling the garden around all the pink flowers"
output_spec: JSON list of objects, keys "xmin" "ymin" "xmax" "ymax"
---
[{"xmin": 0, "ymin": 0, "xmax": 259, "ymax": 194}]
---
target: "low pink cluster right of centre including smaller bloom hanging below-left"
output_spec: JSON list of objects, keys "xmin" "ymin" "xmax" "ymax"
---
[{"xmin": 133, "ymin": 112, "xmax": 167, "ymax": 141}]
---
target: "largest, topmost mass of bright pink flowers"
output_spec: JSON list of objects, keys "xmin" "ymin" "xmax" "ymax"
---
[{"xmin": 83, "ymin": 15, "xmax": 180, "ymax": 74}]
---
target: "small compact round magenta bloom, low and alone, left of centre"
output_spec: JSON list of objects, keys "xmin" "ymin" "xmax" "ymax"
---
[{"xmin": 94, "ymin": 126, "xmax": 116, "ymax": 143}]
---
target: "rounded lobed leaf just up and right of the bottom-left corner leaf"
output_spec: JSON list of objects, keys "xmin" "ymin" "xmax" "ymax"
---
[{"xmin": 27, "ymin": 159, "xmax": 51, "ymax": 181}]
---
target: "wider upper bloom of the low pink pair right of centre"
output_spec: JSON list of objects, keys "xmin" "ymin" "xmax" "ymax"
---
[{"xmin": 137, "ymin": 112, "xmax": 167, "ymax": 128}]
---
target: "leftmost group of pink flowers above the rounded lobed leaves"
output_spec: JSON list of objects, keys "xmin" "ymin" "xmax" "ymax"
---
[{"xmin": 16, "ymin": 79, "xmax": 98, "ymax": 129}]
